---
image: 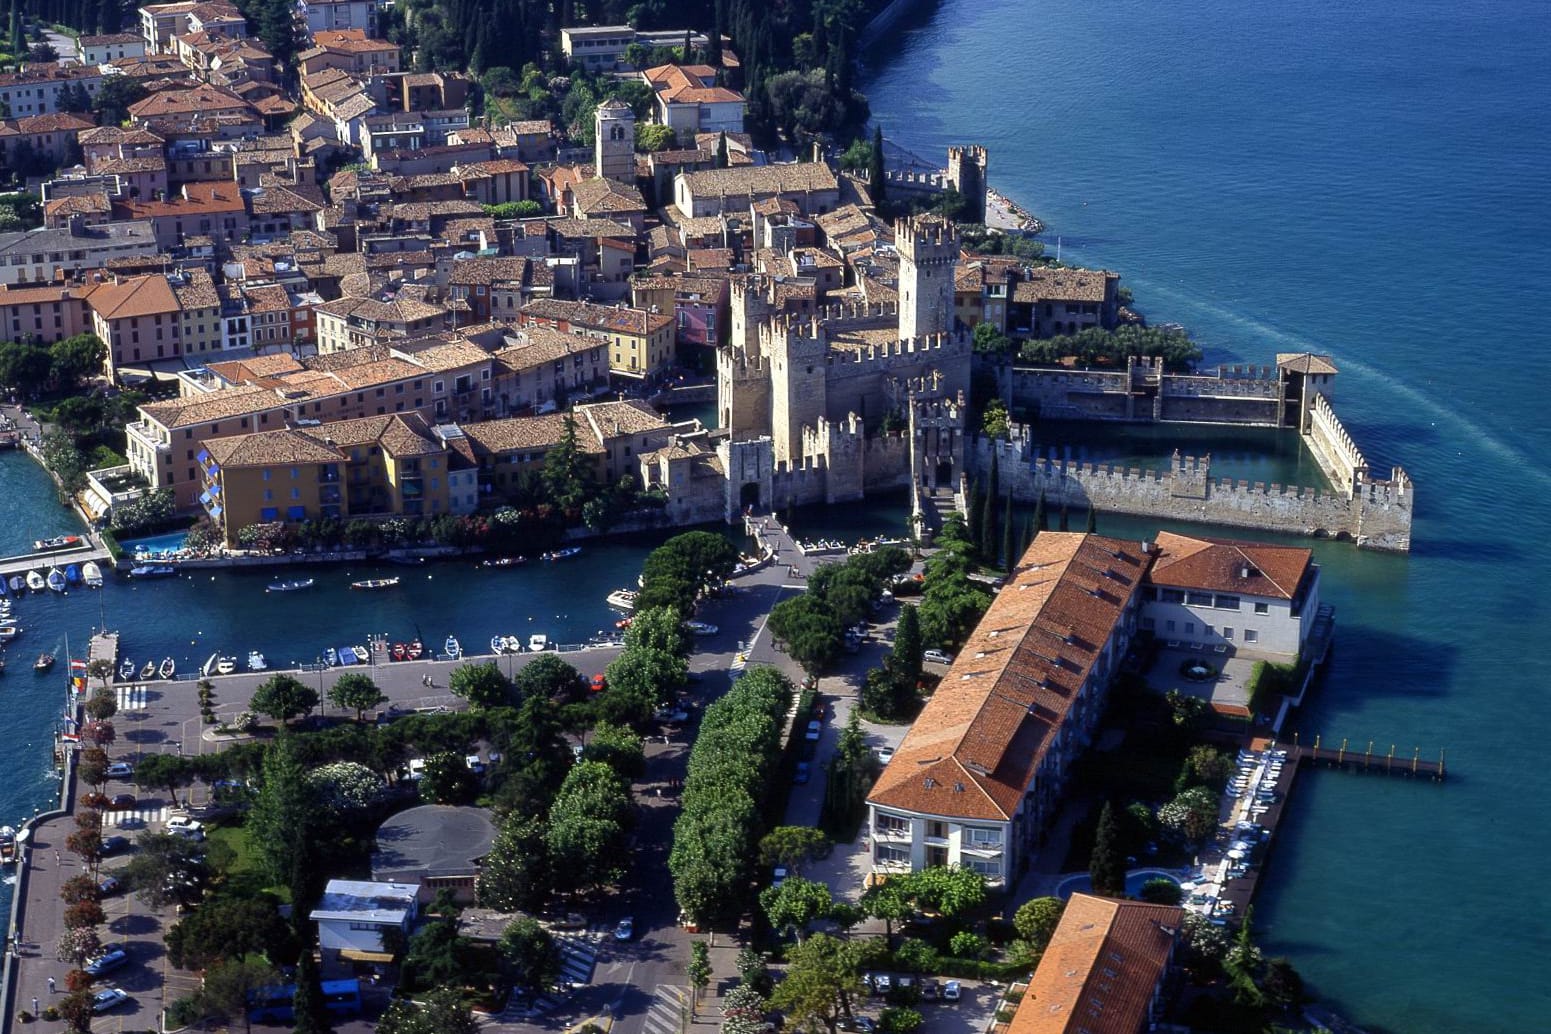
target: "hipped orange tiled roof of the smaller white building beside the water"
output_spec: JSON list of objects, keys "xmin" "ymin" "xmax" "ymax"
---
[{"xmin": 1148, "ymin": 532, "xmax": 1314, "ymax": 600}]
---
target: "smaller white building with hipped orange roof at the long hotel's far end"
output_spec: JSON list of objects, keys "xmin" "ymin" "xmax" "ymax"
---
[{"xmin": 1142, "ymin": 532, "xmax": 1320, "ymax": 662}]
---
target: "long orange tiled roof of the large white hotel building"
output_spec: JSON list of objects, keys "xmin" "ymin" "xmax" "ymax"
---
[{"xmin": 867, "ymin": 532, "xmax": 1145, "ymax": 822}]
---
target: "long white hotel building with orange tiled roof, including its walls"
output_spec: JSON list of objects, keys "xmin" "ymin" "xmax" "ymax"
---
[{"xmin": 867, "ymin": 532, "xmax": 1148, "ymax": 887}]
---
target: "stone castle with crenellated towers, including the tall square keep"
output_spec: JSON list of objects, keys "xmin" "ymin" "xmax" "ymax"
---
[{"xmin": 717, "ymin": 215, "xmax": 972, "ymax": 516}]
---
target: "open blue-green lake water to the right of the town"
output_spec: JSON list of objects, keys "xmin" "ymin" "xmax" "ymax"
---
[{"xmin": 862, "ymin": 0, "xmax": 1551, "ymax": 1034}]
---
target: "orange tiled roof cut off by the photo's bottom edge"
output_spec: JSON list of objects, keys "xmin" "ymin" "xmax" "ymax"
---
[{"xmin": 1007, "ymin": 894, "xmax": 1185, "ymax": 1034}]
